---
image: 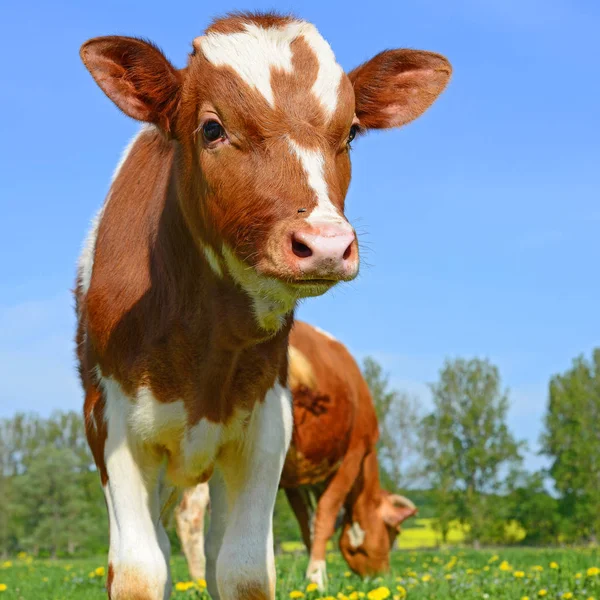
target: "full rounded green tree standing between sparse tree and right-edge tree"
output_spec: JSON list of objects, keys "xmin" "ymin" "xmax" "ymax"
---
[{"xmin": 421, "ymin": 359, "xmax": 523, "ymax": 546}]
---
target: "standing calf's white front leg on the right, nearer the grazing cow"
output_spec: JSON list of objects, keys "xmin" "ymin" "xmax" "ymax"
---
[{"xmin": 216, "ymin": 385, "xmax": 292, "ymax": 600}]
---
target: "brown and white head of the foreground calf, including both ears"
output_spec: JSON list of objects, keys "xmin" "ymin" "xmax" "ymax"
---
[{"xmin": 81, "ymin": 14, "xmax": 451, "ymax": 328}]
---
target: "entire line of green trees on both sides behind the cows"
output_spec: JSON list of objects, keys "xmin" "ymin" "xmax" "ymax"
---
[{"xmin": 0, "ymin": 349, "xmax": 600, "ymax": 556}]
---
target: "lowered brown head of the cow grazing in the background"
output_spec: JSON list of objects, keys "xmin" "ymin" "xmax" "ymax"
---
[{"xmin": 339, "ymin": 490, "xmax": 417, "ymax": 577}]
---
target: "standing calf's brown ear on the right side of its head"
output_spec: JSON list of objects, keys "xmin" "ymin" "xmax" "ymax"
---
[{"xmin": 348, "ymin": 49, "xmax": 452, "ymax": 129}]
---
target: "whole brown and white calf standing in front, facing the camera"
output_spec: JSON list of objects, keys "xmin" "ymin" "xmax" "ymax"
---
[{"xmin": 75, "ymin": 14, "xmax": 450, "ymax": 600}]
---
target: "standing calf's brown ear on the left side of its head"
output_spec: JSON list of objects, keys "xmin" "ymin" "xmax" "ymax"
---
[{"xmin": 79, "ymin": 36, "xmax": 181, "ymax": 133}]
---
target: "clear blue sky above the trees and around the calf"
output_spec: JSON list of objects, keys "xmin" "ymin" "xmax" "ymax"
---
[{"xmin": 0, "ymin": 0, "xmax": 600, "ymax": 468}]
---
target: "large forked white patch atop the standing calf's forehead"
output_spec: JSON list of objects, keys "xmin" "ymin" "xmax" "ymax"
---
[{"xmin": 199, "ymin": 21, "xmax": 343, "ymax": 116}]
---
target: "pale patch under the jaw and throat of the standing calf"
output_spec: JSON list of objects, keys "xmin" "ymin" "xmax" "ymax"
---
[{"xmin": 223, "ymin": 244, "xmax": 296, "ymax": 332}]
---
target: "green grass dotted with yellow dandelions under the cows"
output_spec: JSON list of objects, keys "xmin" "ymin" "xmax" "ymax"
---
[{"xmin": 0, "ymin": 549, "xmax": 600, "ymax": 600}]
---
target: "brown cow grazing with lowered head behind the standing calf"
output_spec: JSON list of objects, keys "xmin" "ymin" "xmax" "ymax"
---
[{"xmin": 178, "ymin": 321, "xmax": 416, "ymax": 589}]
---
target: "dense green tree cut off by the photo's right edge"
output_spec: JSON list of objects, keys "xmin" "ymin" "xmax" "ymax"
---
[{"xmin": 542, "ymin": 348, "xmax": 600, "ymax": 541}]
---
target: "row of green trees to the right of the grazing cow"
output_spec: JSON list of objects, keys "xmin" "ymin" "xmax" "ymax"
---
[{"xmin": 364, "ymin": 348, "xmax": 600, "ymax": 546}]
